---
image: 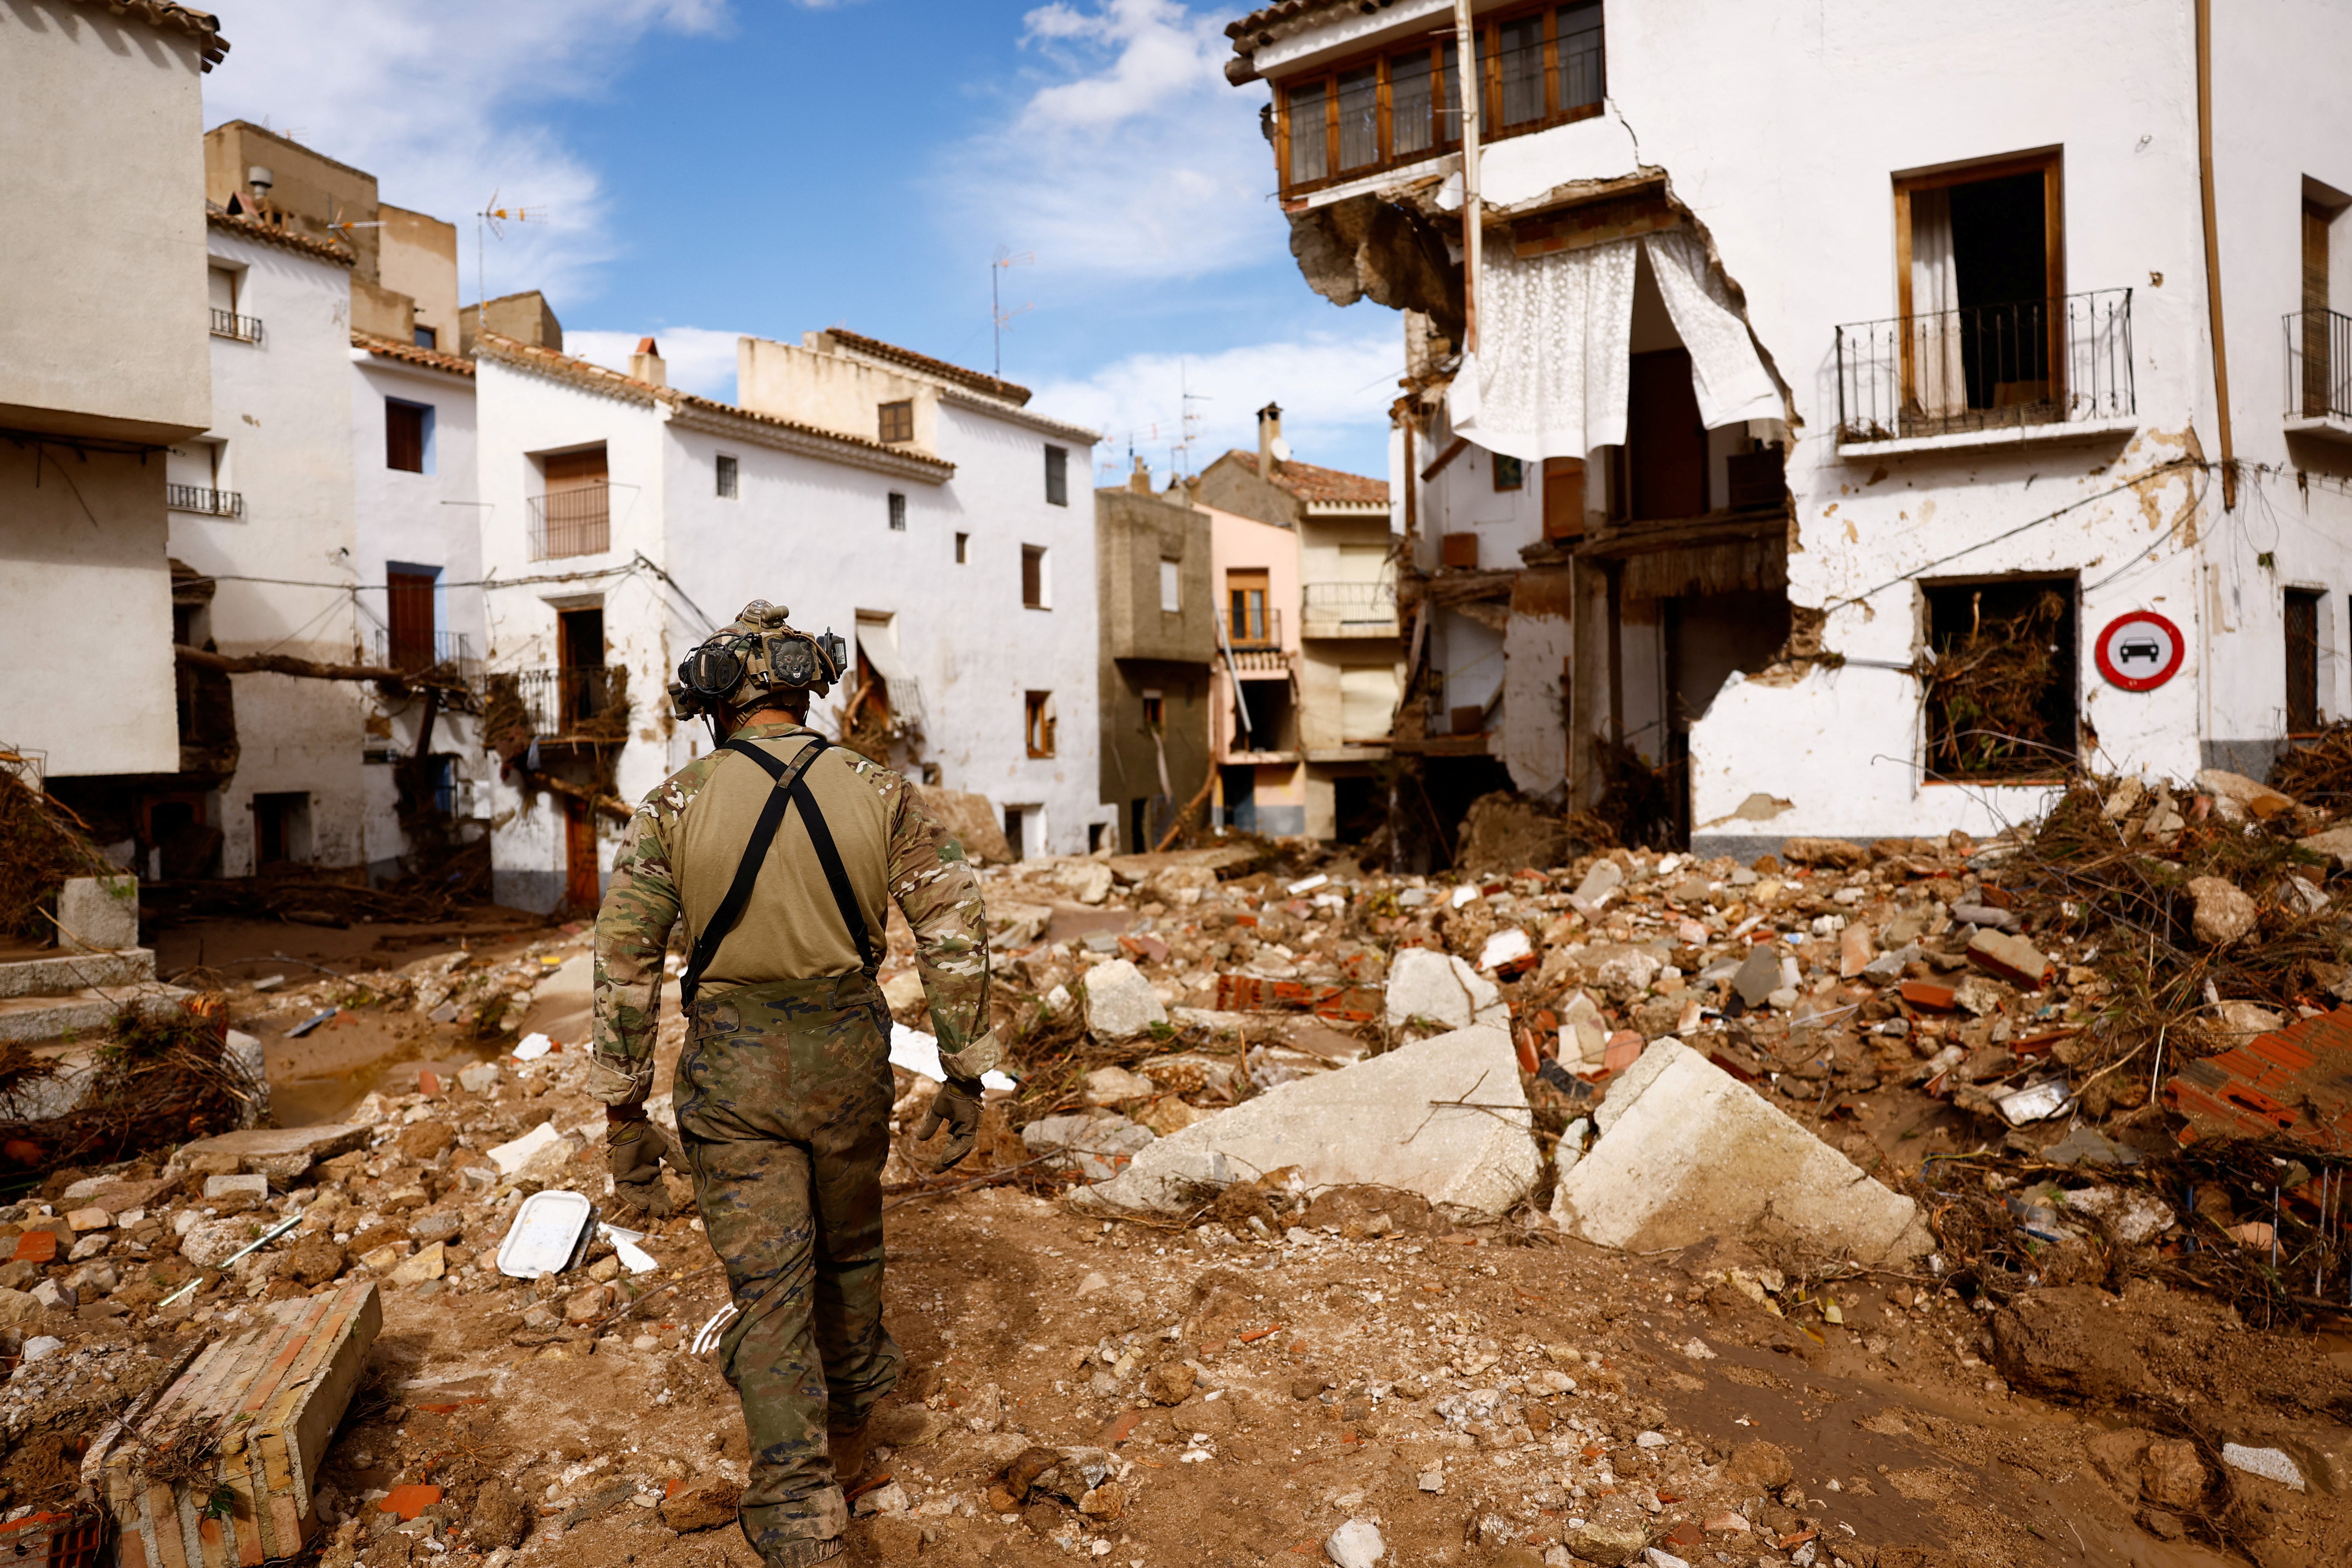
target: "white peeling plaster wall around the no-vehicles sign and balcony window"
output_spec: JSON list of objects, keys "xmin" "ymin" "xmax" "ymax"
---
[{"xmin": 1261, "ymin": 0, "xmax": 2352, "ymax": 849}]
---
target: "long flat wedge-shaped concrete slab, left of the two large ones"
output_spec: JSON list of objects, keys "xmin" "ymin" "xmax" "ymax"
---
[{"xmin": 1073, "ymin": 1028, "xmax": 1541, "ymax": 1218}]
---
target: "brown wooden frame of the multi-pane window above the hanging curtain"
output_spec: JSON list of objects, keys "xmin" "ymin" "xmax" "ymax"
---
[{"xmin": 1275, "ymin": 0, "xmax": 1609, "ymax": 198}]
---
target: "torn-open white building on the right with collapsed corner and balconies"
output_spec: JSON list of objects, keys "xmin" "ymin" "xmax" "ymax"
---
[{"xmin": 1228, "ymin": 0, "xmax": 2352, "ymax": 853}]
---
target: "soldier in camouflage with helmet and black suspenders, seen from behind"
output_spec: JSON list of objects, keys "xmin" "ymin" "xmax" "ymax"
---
[{"xmin": 591, "ymin": 602, "xmax": 997, "ymax": 1568}]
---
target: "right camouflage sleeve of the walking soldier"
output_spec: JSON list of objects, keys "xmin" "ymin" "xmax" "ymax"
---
[{"xmin": 889, "ymin": 788, "xmax": 1000, "ymax": 1079}]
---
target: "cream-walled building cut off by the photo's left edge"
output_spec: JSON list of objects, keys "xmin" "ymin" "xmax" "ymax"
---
[{"xmin": 0, "ymin": 0, "xmax": 228, "ymax": 809}]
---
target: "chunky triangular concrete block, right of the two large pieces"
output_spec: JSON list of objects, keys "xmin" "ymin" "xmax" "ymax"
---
[{"xmin": 1543, "ymin": 1039, "xmax": 1933, "ymax": 1265}]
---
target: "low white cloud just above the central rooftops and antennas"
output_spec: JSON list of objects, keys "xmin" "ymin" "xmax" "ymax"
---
[{"xmin": 1030, "ymin": 327, "xmax": 1404, "ymax": 484}]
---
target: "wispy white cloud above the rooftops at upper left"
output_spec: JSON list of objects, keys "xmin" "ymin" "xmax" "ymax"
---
[{"xmin": 205, "ymin": 0, "xmax": 727, "ymax": 315}]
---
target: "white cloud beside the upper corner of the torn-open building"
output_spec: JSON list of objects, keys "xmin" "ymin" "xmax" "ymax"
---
[{"xmin": 936, "ymin": 0, "xmax": 1284, "ymax": 280}]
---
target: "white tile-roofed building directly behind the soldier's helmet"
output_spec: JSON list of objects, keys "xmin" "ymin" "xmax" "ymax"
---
[{"xmin": 475, "ymin": 331, "xmax": 1113, "ymax": 910}]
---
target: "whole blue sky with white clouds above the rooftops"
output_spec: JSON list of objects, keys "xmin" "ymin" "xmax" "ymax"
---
[{"xmin": 205, "ymin": 0, "xmax": 1402, "ymax": 480}]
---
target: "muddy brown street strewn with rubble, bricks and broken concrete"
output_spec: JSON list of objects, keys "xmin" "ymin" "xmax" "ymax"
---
[{"xmin": 0, "ymin": 757, "xmax": 2352, "ymax": 1568}]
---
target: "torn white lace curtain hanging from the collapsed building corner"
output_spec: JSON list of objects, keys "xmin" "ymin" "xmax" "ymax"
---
[{"xmin": 1451, "ymin": 230, "xmax": 1783, "ymax": 463}]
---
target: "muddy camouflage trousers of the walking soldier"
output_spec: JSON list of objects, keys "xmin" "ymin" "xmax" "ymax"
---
[{"xmin": 675, "ymin": 971, "xmax": 901, "ymax": 1556}]
